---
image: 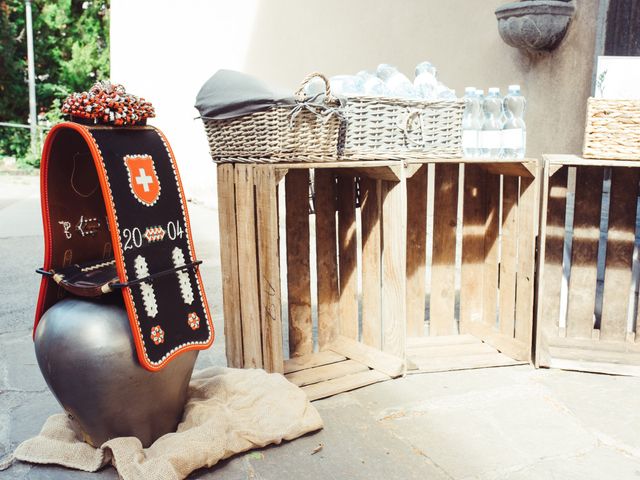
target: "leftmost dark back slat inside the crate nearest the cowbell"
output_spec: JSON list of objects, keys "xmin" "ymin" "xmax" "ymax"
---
[{"xmin": 284, "ymin": 170, "xmax": 313, "ymax": 357}]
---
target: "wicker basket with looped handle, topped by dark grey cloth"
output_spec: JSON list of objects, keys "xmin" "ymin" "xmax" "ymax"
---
[{"xmin": 203, "ymin": 73, "xmax": 344, "ymax": 163}]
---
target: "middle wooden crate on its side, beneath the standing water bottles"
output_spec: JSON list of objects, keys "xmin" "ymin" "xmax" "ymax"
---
[{"xmin": 406, "ymin": 160, "xmax": 539, "ymax": 373}]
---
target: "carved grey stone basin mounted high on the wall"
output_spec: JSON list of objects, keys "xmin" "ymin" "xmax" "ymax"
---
[{"xmin": 495, "ymin": 0, "xmax": 576, "ymax": 52}]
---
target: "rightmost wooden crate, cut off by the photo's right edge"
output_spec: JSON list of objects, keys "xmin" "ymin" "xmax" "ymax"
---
[{"xmin": 536, "ymin": 155, "xmax": 640, "ymax": 375}]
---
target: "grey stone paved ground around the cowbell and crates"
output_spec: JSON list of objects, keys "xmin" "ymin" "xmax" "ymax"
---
[{"xmin": 0, "ymin": 175, "xmax": 640, "ymax": 480}]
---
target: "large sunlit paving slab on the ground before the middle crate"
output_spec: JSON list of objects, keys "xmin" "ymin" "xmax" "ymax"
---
[{"xmin": 376, "ymin": 376, "xmax": 596, "ymax": 478}]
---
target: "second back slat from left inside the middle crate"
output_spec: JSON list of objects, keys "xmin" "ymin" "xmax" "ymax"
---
[{"xmin": 429, "ymin": 164, "xmax": 458, "ymax": 335}]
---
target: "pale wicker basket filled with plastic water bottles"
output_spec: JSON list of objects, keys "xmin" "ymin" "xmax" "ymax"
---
[{"xmin": 341, "ymin": 96, "xmax": 464, "ymax": 160}]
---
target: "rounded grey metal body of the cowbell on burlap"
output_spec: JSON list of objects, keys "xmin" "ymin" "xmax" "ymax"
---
[{"xmin": 35, "ymin": 295, "xmax": 198, "ymax": 447}]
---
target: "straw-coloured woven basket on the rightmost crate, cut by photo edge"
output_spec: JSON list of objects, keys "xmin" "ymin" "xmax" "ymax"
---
[{"xmin": 582, "ymin": 98, "xmax": 640, "ymax": 160}]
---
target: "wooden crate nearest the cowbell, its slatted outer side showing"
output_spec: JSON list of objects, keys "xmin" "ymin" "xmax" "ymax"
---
[{"xmin": 218, "ymin": 162, "xmax": 404, "ymax": 399}]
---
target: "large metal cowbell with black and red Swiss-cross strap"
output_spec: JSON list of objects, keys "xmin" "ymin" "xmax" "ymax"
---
[{"xmin": 34, "ymin": 107, "xmax": 214, "ymax": 446}]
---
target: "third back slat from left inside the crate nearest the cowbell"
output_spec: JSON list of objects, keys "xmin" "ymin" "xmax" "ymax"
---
[{"xmin": 338, "ymin": 176, "xmax": 358, "ymax": 340}]
